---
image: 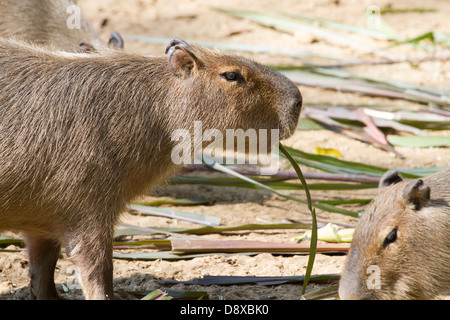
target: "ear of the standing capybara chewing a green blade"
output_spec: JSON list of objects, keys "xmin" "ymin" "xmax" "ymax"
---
[{"xmin": 165, "ymin": 37, "xmax": 199, "ymax": 78}]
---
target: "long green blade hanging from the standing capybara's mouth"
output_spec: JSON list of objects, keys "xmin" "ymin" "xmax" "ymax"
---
[{"xmin": 279, "ymin": 143, "xmax": 317, "ymax": 295}]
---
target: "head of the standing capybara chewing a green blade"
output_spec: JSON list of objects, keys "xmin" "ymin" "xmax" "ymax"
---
[{"xmin": 166, "ymin": 37, "xmax": 302, "ymax": 139}]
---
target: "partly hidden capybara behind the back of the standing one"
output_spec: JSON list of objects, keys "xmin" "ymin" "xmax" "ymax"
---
[{"xmin": 0, "ymin": 0, "xmax": 123, "ymax": 52}]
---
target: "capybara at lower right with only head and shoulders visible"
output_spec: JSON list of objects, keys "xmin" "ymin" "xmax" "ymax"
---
[{"xmin": 339, "ymin": 168, "xmax": 450, "ymax": 299}]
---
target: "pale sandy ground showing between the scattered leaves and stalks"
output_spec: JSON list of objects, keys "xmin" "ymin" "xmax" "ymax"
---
[{"xmin": 0, "ymin": 0, "xmax": 450, "ymax": 300}]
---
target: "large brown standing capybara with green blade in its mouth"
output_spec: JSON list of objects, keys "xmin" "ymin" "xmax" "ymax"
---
[{"xmin": 0, "ymin": 38, "xmax": 302, "ymax": 299}]
